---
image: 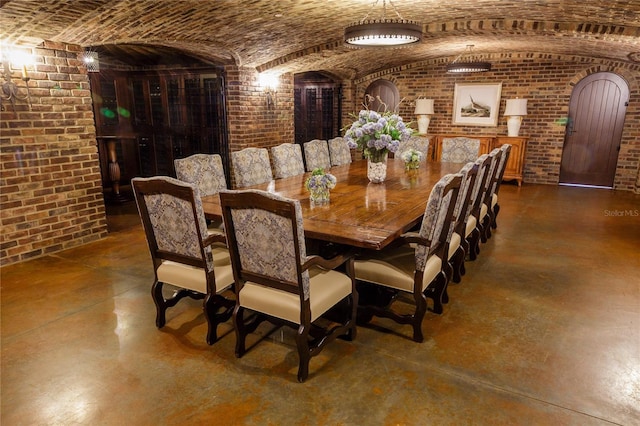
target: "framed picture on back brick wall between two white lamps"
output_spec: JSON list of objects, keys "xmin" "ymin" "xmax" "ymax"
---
[{"xmin": 453, "ymin": 83, "xmax": 502, "ymax": 127}]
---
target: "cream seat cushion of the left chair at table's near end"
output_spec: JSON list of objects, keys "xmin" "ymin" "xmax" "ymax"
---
[{"xmin": 156, "ymin": 245, "xmax": 233, "ymax": 294}]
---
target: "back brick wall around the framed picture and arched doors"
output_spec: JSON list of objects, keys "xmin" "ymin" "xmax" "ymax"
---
[{"xmin": 344, "ymin": 53, "xmax": 640, "ymax": 192}]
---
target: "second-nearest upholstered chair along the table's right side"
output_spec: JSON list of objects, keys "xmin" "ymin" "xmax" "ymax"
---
[{"xmin": 445, "ymin": 162, "xmax": 478, "ymax": 284}]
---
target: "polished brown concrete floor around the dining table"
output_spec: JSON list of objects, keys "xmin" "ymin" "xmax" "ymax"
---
[{"xmin": 0, "ymin": 184, "xmax": 640, "ymax": 426}]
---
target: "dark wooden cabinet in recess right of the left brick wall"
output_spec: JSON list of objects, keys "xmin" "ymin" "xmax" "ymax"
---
[{"xmin": 91, "ymin": 70, "xmax": 230, "ymax": 197}]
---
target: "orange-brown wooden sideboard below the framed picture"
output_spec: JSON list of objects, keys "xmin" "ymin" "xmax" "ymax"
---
[{"xmin": 429, "ymin": 135, "xmax": 529, "ymax": 186}]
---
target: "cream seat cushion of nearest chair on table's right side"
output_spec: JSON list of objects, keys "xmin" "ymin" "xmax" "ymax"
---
[{"xmin": 354, "ymin": 247, "xmax": 442, "ymax": 293}]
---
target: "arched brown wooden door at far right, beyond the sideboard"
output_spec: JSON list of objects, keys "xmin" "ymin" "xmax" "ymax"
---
[{"xmin": 560, "ymin": 72, "xmax": 629, "ymax": 188}]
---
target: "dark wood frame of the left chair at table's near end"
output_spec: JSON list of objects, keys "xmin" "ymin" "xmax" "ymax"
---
[{"xmin": 132, "ymin": 179, "xmax": 235, "ymax": 345}]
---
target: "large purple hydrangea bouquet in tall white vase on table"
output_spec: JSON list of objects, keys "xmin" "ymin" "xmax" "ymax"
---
[{"xmin": 344, "ymin": 98, "xmax": 413, "ymax": 183}]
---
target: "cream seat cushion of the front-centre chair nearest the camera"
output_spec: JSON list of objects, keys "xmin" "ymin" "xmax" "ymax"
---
[{"xmin": 238, "ymin": 267, "xmax": 352, "ymax": 324}]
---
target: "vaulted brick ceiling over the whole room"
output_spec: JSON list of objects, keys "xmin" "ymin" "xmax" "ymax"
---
[{"xmin": 0, "ymin": 0, "xmax": 640, "ymax": 78}]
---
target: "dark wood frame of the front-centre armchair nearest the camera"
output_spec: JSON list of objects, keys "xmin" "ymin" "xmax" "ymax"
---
[{"xmin": 220, "ymin": 191, "xmax": 358, "ymax": 382}]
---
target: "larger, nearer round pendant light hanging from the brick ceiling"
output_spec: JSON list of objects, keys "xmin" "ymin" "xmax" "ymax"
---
[{"xmin": 344, "ymin": 0, "xmax": 422, "ymax": 47}]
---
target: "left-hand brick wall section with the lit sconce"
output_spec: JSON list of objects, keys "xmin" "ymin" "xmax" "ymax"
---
[{"xmin": 0, "ymin": 43, "xmax": 107, "ymax": 265}]
